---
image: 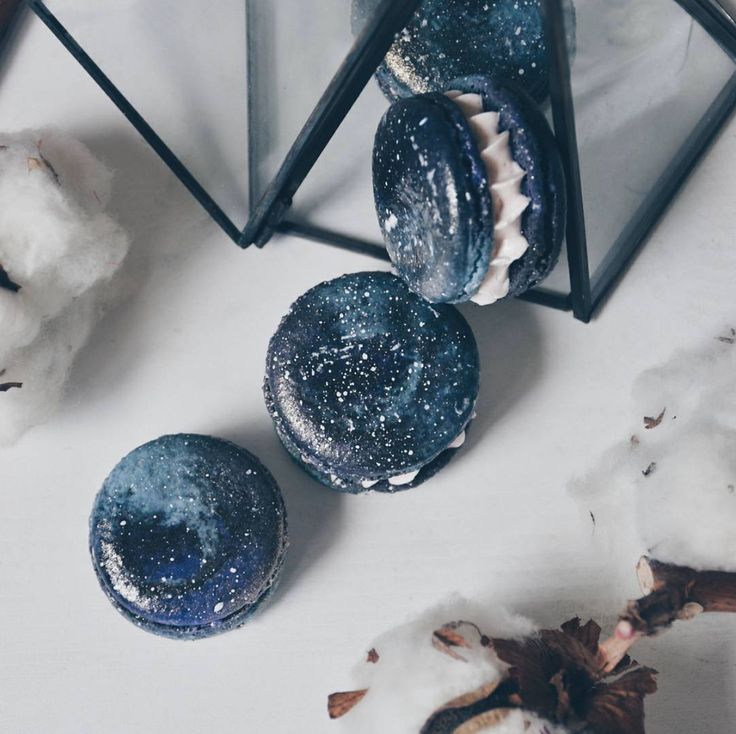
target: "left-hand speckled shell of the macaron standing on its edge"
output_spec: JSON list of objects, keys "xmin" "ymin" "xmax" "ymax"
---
[{"xmin": 373, "ymin": 98, "xmax": 494, "ymax": 303}]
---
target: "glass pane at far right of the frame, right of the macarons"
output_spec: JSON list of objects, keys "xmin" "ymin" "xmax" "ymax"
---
[{"xmin": 572, "ymin": 0, "xmax": 736, "ymax": 280}]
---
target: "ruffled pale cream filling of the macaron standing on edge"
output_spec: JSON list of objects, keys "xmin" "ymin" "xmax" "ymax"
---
[{"xmin": 446, "ymin": 90, "xmax": 531, "ymax": 306}]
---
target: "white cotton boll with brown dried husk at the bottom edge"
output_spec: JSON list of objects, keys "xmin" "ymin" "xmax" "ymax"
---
[{"xmin": 328, "ymin": 607, "xmax": 656, "ymax": 734}]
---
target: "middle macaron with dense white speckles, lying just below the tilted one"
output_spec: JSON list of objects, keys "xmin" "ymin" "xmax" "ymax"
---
[{"xmin": 264, "ymin": 272, "xmax": 479, "ymax": 493}]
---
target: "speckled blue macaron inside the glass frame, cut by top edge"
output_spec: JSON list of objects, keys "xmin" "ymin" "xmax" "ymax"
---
[{"xmin": 352, "ymin": 0, "xmax": 575, "ymax": 102}]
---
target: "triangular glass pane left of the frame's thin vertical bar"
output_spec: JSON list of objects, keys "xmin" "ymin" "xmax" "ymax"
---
[{"xmin": 41, "ymin": 0, "xmax": 248, "ymax": 227}]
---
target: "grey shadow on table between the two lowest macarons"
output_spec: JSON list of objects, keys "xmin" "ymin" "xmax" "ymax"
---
[{"xmin": 215, "ymin": 426, "xmax": 354, "ymax": 604}]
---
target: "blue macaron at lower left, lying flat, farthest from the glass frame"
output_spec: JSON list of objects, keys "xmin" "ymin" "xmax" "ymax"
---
[{"xmin": 90, "ymin": 434, "xmax": 287, "ymax": 639}]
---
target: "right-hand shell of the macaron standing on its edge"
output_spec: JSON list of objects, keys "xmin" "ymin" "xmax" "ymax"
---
[{"xmin": 450, "ymin": 77, "xmax": 567, "ymax": 297}]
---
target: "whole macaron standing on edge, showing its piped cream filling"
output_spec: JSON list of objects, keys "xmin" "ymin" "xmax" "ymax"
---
[{"xmin": 373, "ymin": 77, "xmax": 567, "ymax": 305}]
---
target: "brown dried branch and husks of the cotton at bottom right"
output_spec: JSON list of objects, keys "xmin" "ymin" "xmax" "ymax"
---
[{"xmin": 329, "ymin": 560, "xmax": 736, "ymax": 734}]
